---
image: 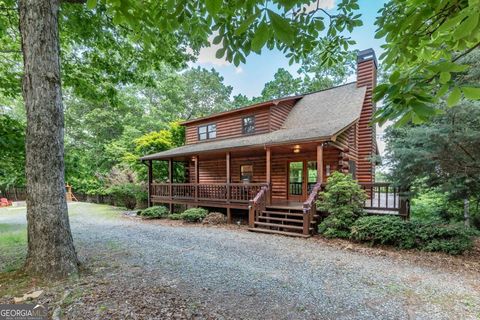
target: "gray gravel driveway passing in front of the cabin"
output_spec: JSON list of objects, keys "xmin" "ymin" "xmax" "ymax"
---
[{"xmin": 0, "ymin": 204, "xmax": 480, "ymax": 319}]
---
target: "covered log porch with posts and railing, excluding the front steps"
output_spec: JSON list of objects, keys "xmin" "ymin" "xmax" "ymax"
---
[{"xmin": 142, "ymin": 142, "xmax": 336, "ymax": 220}]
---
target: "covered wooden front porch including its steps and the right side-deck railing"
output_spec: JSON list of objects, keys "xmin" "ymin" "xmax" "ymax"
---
[{"xmin": 145, "ymin": 141, "xmax": 408, "ymax": 235}]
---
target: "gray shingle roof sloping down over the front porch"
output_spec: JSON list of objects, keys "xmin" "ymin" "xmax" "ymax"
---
[{"xmin": 141, "ymin": 82, "xmax": 366, "ymax": 160}]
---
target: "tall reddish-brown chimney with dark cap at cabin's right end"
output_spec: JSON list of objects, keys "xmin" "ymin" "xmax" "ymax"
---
[{"xmin": 356, "ymin": 49, "xmax": 377, "ymax": 183}]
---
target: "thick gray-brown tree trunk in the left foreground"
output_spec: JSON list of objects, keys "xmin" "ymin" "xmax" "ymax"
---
[{"xmin": 19, "ymin": 0, "xmax": 78, "ymax": 278}]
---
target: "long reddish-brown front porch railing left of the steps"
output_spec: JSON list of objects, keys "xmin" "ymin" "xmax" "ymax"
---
[{"xmin": 150, "ymin": 183, "xmax": 267, "ymax": 203}]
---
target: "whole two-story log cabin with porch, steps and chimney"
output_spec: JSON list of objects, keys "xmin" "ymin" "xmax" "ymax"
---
[{"xmin": 141, "ymin": 49, "xmax": 408, "ymax": 237}]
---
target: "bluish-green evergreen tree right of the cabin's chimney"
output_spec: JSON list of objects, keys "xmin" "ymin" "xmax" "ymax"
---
[{"xmin": 385, "ymin": 50, "xmax": 480, "ymax": 199}]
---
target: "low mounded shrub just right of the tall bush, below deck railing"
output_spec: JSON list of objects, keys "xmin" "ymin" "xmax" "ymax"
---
[{"xmin": 350, "ymin": 216, "xmax": 415, "ymax": 248}]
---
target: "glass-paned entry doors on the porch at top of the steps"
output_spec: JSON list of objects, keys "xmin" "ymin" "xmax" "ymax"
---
[{"xmin": 288, "ymin": 161, "xmax": 317, "ymax": 201}]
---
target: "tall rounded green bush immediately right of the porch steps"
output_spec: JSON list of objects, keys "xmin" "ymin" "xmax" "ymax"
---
[{"xmin": 317, "ymin": 172, "xmax": 366, "ymax": 238}]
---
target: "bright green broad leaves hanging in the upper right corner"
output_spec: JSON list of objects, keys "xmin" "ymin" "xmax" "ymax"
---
[{"xmin": 375, "ymin": 0, "xmax": 480, "ymax": 125}]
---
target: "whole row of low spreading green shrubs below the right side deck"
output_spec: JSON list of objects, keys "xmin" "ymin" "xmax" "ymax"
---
[{"xmin": 350, "ymin": 216, "xmax": 474, "ymax": 255}]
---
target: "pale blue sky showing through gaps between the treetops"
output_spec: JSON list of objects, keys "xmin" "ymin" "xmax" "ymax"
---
[{"xmin": 191, "ymin": 0, "xmax": 384, "ymax": 97}]
